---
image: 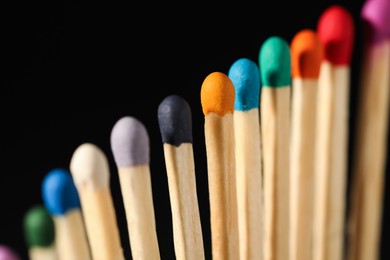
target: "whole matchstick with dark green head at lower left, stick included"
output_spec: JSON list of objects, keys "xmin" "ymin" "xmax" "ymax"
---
[{"xmin": 23, "ymin": 204, "xmax": 59, "ymax": 260}]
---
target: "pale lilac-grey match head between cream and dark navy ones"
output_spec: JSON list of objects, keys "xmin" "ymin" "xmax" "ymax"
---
[{"xmin": 110, "ymin": 116, "xmax": 150, "ymax": 168}]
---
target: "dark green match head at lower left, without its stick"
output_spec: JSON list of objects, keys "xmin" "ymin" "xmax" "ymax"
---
[{"xmin": 23, "ymin": 204, "xmax": 55, "ymax": 248}]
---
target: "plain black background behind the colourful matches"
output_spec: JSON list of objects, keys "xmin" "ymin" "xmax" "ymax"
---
[{"xmin": 0, "ymin": 0, "xmax": 390, "ymax": 259}]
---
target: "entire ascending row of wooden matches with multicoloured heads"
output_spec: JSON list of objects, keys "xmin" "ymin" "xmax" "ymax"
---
[{"xmin": 0, "ymin": 0, "xmax": 390, "ymax": 260}]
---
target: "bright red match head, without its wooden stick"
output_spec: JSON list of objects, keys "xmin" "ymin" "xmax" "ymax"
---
[{"xmin": 317, "ymin": 5, "xmax": 355, "ymax": 66}]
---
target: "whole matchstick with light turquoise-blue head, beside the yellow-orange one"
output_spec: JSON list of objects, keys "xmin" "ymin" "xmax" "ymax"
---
[{"xmin": 228, "ymin": 58, "xmax": 264, "ymax": 260}]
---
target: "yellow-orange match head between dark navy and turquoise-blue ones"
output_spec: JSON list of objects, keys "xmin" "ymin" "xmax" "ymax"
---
[{"xmin": 200, "ymin": 72, "xmax": 236, "ymax": 116}]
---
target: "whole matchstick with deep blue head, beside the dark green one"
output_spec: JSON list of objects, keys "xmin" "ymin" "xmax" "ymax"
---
[{"xmin": 42, "ymin": 168, "xmax": 92, "ymax": 260}]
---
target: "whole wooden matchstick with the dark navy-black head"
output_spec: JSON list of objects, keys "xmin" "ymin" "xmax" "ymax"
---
[{"xmin": 157, "ymin": 95, "xmax": 205, "ymax": 260}]
